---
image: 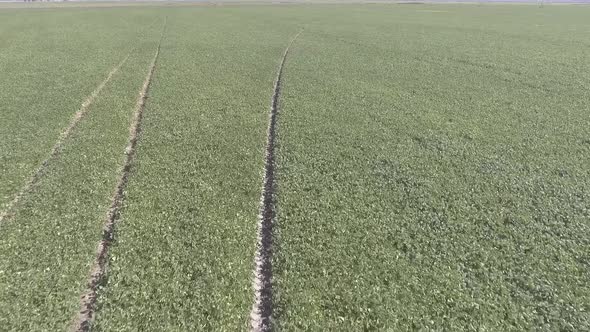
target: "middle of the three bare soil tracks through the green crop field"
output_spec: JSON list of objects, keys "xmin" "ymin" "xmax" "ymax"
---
[{"xmin": 71, "ymin": 18, "xmax": 168, "ymax": 331}]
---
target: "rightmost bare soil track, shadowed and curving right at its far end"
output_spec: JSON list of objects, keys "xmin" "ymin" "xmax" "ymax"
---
[{"xmin": 250, "ymin": 29, "xmax": 303, "ymax": 332}]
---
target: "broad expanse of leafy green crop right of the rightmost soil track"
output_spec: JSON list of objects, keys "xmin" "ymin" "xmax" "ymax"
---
[{"xmin": 274, "ymin": 6, "xmax": 590, "ymax": 331}]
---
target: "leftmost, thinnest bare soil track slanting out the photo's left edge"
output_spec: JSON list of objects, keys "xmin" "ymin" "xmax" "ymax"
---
[{"xmin": 0, "ymin": 50, "xmax": 133, "ymax": 224}]
